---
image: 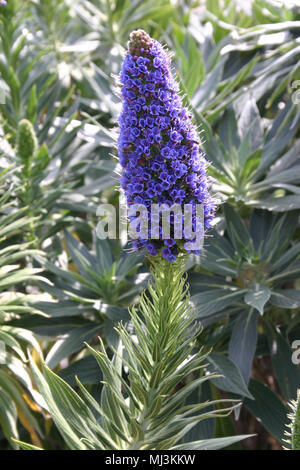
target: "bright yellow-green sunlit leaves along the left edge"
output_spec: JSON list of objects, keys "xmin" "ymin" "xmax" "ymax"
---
[{"xmin": 0, "ymin": 170, "xmax": 43, "ymax": 442}]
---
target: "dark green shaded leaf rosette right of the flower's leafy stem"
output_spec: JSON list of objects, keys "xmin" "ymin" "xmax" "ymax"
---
[{"xmin": 190, "ymin": 205, "xmax": 300, "ymax": 414}]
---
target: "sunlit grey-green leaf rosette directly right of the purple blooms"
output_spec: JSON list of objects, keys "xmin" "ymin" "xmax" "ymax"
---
[{"xmin": 199, "ymin": 104, "xmax": 300, "ymax": 212}]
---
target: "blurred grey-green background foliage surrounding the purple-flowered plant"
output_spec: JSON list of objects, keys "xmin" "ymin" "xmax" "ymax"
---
[{"xmin": 0, "ymin": 0, "xmax": 300, "ymax": 449}]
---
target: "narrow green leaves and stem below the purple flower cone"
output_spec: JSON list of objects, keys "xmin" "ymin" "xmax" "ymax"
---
[{"xmin": 14, "ymin": 260, "xmax": 251, "ymax": 450}]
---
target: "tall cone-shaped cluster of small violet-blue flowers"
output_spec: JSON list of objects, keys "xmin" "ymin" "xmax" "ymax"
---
[{"xmin": 118, "ymin": 30, "xmax": 215, "ymax": 262}]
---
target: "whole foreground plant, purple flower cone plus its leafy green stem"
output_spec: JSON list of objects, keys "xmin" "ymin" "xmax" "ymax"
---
[{"xmin": 12, "ymin": 31, "xmax": 248, "ymax": 450}]
